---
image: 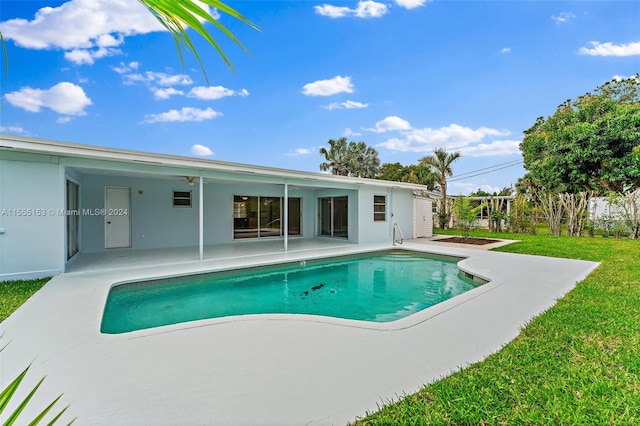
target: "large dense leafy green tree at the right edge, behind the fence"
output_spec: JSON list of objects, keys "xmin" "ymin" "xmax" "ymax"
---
[{"xmin": 520, "ymin": 74, "xmax": 640, "ymax": 193}]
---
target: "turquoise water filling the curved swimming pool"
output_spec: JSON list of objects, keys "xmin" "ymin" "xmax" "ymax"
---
[{"xmin": 101, "ymin": 250, "xmax": 477, "ymax": 334}]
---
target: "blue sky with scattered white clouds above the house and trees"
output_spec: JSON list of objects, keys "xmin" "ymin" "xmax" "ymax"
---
[{"xmin": 0, "ymin": 0, "xmax": 640, "ymax": 194}]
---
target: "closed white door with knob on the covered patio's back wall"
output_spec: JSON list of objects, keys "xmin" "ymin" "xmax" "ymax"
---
[{"xmin": 104, "ymin": 187, "xmax": 131, "ymax": 248}]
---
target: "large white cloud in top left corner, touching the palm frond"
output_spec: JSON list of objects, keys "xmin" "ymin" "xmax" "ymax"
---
[{"xmin": 0, "ymin": 0, "xmax": 217, "ymax": 64}]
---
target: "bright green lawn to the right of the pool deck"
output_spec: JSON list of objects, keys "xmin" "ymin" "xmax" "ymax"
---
[{"xmin": 356, "ymin": 231, "xmax": 640, "ymax": 425}]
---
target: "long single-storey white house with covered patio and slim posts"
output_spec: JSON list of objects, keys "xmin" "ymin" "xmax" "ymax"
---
[{"xmin": 0, "ymin": 135, "xmax": 433, "ymax": 280}]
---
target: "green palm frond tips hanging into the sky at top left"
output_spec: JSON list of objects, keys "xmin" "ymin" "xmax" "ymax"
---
[{"xmin": 0, "ymin": 0, "xmax": 259, "ymax": 83}]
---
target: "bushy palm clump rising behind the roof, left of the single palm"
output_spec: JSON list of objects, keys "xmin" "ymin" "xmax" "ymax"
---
[{"xmin": 320, "ymin": 137, "xmax": 380, "ymax": 178}]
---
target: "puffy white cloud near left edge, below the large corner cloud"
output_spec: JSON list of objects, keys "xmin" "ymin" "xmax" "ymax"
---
[{"xmin": 4, "ymin": 82, "xmax": 92, "ymax": 115}]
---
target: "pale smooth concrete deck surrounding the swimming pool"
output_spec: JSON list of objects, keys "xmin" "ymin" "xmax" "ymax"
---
[{"xmin": 0, "ymin": 240, "xmax": 597, "ymax": 425}]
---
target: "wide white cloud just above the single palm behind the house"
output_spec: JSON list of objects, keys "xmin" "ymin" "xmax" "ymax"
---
[{"xmin": 378, "ymin": 124, "xmax": 510, "ymax": 152}]
